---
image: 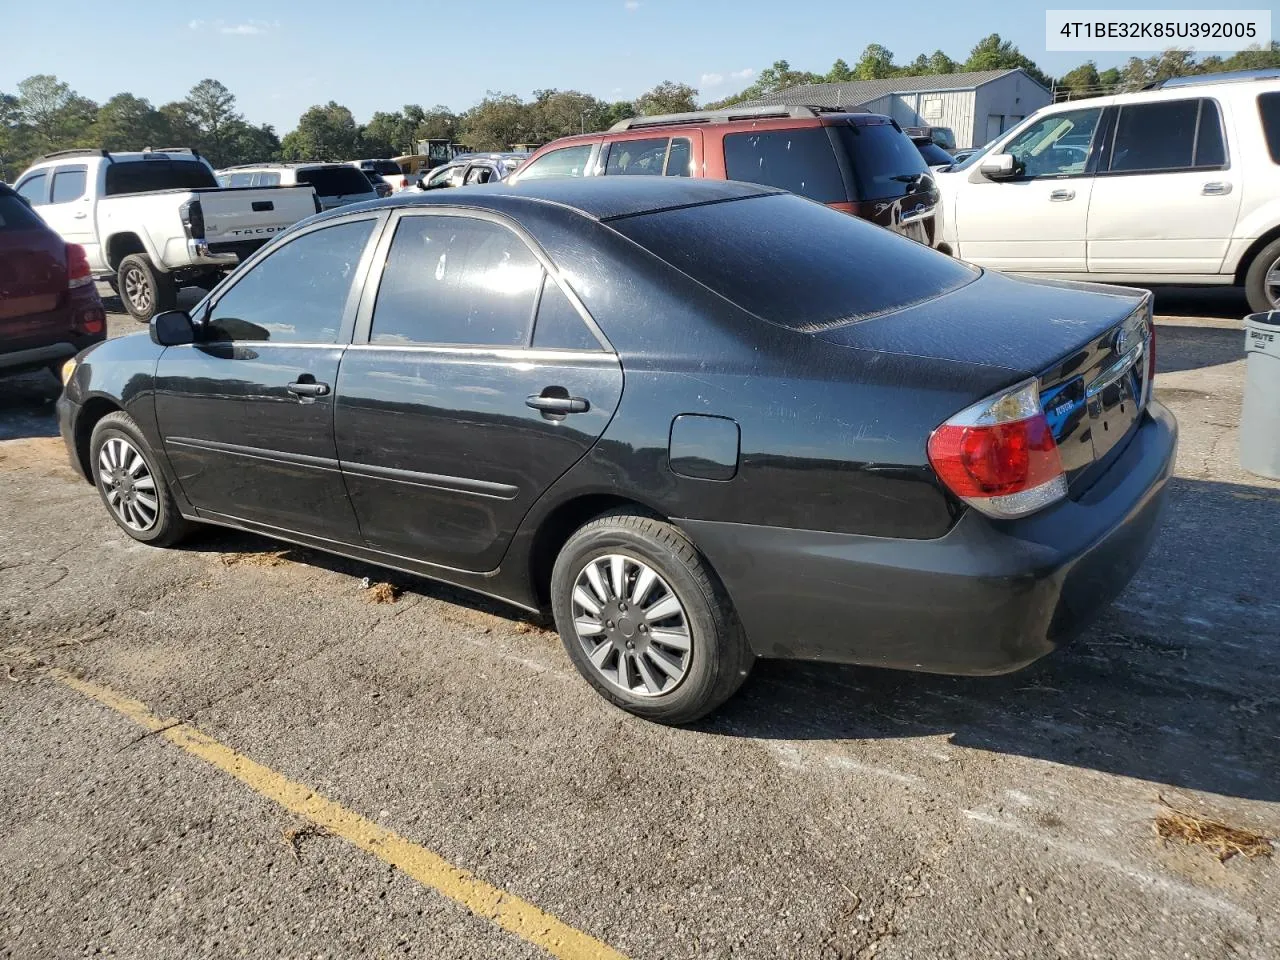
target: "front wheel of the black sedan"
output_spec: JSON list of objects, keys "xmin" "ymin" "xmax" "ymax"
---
[{"xmin": 88, "ymin": 411, "xmax": 195, "ymax": 547}]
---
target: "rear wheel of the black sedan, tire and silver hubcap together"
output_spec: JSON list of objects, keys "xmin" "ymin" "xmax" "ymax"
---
[{"xmin": 552, "ymin": 512, "xmax": 753, "ymax": 723}]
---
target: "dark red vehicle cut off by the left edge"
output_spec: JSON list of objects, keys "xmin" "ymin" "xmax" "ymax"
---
[{"xmin": 0, "ymin": 184, "xmax": 106, "ymax": 374}]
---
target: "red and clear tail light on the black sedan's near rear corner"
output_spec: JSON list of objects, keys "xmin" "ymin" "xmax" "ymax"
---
[{"xmin": 928, "ymin": 380, "xmax": 1066, "ymax": 520}]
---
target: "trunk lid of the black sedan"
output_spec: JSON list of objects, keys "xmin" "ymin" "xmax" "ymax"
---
[{"xmin": 822, "ymin": 271, "xmax": 1151, "ymax": 497}]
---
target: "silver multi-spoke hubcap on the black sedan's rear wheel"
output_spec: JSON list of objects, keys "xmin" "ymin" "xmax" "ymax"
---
[{"xmin": 572, "ymin": 553, "xmax": 692, "ymax": 696}]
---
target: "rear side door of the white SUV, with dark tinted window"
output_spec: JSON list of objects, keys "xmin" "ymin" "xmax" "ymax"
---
[{"xmin": 1088, "ymin": 97, "xmax": 1243, "ymax": 275}]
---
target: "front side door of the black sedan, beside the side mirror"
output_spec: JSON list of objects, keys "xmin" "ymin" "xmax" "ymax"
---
[{"xmin": 155, "ymin": 214, "xmax": 380, "ymax": 543}]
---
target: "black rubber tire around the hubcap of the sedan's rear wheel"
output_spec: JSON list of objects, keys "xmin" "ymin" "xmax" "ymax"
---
[{"xmin": 550, "ymin": 511, "xmax": 754, "ymax": 724}]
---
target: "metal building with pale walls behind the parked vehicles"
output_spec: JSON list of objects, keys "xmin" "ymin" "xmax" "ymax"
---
[{"xmin": 751, "ymin": 67, "xmax": 1052, "ymax": 148}]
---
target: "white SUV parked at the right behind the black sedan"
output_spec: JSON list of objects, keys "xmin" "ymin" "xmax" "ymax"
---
[{"xmin": 936, "ymin": 70, "xmax": 1280, "ymax": 310}]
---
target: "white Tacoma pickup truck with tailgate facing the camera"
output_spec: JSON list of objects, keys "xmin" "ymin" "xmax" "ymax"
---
[{"xmin": 14, "ymin": 148, "xmax": 320, "ymax": 323}]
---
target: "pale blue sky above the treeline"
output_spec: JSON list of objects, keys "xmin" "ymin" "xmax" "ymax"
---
[{"xmin": 0, "ymin": 0, "xmax": 1228, "ymax": 134}]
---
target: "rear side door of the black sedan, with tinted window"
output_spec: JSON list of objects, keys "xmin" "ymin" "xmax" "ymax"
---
[{"xmin": 335, "ymin": 210, "xmax": 622, "ymax": 571}]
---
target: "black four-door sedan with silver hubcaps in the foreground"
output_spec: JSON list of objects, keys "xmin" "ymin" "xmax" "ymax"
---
[{"xmin": 59, "ymin": 177, "xmax": 1176, "ymax": 723}]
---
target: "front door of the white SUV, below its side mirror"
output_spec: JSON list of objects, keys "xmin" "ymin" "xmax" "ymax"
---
[{"xmin": 952, "ymin": 108, "xmax": 1102, "ymax": 273}]
